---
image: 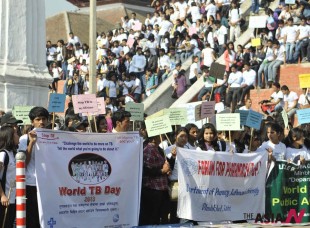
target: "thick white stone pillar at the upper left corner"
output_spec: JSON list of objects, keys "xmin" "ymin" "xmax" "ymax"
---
[{"xmin": 0, "ymin": 0, "xmax": 52, "ymax": 111}]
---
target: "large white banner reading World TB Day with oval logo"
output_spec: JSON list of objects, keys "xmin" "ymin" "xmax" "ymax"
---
[{"xmin": 35, "ymin": 130, "xmax": 143, "ymax": 228}]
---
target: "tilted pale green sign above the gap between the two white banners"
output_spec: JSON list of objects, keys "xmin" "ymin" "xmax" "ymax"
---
[{"xmin": 145, "ymin": 116, "xmax": 172, "ymax": 137}]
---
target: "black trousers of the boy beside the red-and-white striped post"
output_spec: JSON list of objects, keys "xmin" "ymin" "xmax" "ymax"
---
[{"xmin": 26, "ymin": 185, "xmax": 40, "ymax": 228}]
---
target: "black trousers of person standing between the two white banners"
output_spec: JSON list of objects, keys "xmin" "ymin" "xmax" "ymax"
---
[{"xmin": 139, "ymin": 188, "xmax": 169, "ymax": 226}]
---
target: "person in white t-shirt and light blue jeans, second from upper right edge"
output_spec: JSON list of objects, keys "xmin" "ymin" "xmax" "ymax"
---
[{"xmin": 284, "ymin": 17, "xmax": 297, "ymax": 63}]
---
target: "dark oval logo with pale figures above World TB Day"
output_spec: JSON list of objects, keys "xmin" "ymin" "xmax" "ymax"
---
[{"xmin": 68, "ymin": 153, "xmax": 112, "ymax": 185}]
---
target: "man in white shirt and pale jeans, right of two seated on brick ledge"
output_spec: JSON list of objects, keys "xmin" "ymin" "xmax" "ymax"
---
[{"xmin": 268, "ymin": 40, "xmax": 286, "ymax": 83}]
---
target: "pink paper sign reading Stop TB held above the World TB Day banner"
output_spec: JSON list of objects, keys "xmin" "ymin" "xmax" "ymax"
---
[{"xmin": 72, "ymin": 94, "xmax": 98, "ymax": 114}]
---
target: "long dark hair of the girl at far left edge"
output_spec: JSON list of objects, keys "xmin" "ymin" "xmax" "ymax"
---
[{"xmin": 0, "ymin": 126, "xmax": 17, "ymax": 152}]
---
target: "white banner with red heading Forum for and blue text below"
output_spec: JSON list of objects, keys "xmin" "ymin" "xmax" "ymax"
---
[{"xmin": 177, "ymin": 148, "xmax": 267, "ymax": 221}]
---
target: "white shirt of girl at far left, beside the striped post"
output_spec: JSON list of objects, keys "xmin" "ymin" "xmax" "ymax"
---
[{"xmin": 0, "ymin": 150, "xmax": 16, "ymax": 204}]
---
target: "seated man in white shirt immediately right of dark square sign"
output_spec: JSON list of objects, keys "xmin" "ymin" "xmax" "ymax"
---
[{"xmin": 225, "ymin": 65, "xmax": 242, "ymax": 112}]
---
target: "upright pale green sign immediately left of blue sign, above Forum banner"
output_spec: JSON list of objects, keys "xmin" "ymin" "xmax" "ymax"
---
[{"xmin": 216, "ymin": 113, "xmax": 240, "ymax": 131}]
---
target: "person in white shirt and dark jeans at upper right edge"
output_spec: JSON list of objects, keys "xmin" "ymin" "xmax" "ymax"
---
[{"xmin": 293, "ymin": 17, "xmax": 310, "ymax": 63}]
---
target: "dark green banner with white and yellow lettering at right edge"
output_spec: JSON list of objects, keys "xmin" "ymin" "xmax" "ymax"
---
[{"xmin": 266, "ymin": 161, "xmax": 310, "ymax": 223}]
